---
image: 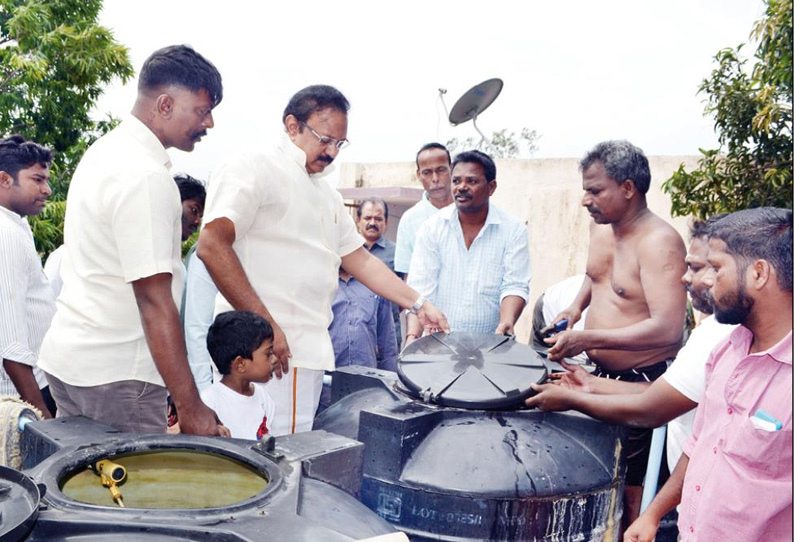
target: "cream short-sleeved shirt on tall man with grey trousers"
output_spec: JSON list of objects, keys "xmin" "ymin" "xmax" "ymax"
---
[{"xmin": 39, "ymin": 116, "xmax": 182, "ymax": 386}]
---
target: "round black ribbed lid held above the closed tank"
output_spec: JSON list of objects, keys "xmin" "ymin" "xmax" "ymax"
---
[{"xmin": 397, "ymin": 332, "xmax": 548, "ymax": 409}]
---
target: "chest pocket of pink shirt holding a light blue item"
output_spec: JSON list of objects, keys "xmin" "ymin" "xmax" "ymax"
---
[{"xmin": 724, "ymin": 418, "xmax": 792, "ymax": 478}]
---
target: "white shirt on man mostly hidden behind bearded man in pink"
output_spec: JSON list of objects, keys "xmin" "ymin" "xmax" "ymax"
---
[{"xmin": 662, "ymin": 316, "xmax": 736, "ymax": 472}]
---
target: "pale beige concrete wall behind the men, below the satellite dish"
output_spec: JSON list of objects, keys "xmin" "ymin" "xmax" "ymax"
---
[{"xmin": 338, "ymin": 156, "xmax": 697, "ymax": 343}]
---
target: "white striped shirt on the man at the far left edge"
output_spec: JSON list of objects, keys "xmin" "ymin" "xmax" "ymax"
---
[{"xmin": 0, "ymin": 206, "xmax": 55, "ymax": 397}]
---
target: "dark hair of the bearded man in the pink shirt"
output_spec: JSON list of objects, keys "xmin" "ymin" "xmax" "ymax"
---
[{"xmin": 709, "ymin": 207, "xmax": 792, "ymax": 292}]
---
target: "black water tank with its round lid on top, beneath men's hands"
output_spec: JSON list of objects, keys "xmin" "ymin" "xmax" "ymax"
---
[{"xmin": 315, "ymin": 333, "xmax": 625, "ymax": 542}]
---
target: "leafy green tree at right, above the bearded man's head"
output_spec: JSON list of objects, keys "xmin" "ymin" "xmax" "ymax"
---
[{"xmin": 663, "ymin": 0, "xmax": 792, "ymax": 218}]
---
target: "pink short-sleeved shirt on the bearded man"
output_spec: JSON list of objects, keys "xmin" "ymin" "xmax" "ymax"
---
[{"xmin": 678, "ymin": 326, "xmax": 792, "ymax": 542}]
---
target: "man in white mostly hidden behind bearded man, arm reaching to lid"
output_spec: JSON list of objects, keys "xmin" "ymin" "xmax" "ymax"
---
[{"xmin": 526, "ymin": 215, "xmax": 735, "ymax": 488}]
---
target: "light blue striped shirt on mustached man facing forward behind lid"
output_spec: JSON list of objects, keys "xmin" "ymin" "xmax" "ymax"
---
[{"xmin": 408, "ymin": 203, "xmax": 531, "ymax": 333}]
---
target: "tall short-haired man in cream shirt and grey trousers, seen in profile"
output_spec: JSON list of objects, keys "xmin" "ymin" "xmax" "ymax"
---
[{"xmin": 40, "ymin": 45, "xmax": 224, "ymax": 435}]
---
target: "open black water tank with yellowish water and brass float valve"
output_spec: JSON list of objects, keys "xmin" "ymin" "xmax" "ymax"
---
[{"xmin": 13, "ymin": 417, "xmax": 401, "ymax": 542}]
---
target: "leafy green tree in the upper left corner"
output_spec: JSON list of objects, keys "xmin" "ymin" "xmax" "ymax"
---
[{"xmin": 0, "ymin": 0, "xmax": 134, "ymax": 254}]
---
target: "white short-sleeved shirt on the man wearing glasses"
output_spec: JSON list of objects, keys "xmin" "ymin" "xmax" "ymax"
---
[{"xmin": 204, "ymin": 136, "xmax": 364, "ymax": 370}]
